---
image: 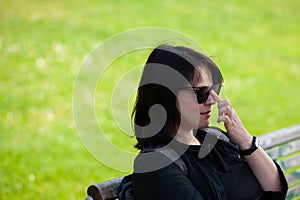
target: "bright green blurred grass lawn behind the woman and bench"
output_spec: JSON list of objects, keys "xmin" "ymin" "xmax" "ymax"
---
[{"xmin": 0, "ymin": 0, "xmax": 300, "ymax": 199}]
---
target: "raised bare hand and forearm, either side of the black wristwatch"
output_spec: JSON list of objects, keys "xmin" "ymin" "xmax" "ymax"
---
[{"xmin": 211, "ymin": 92, "xmax": 282, "ymax": 192}]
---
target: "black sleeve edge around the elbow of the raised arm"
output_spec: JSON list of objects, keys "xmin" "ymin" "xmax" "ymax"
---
[{"xmin": 262, "ymin": 162, "xmax": 288, "ymax": 200}]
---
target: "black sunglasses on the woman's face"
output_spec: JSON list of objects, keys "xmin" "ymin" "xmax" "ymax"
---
[{"xmin": 186, "ymin": 84, "xmax": 222, "ymax": 104}]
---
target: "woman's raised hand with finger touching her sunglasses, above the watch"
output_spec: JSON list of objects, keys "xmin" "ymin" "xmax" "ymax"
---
[{"xmin": 211, "ymin": 91, "xmax": 253, "ymax": 149}]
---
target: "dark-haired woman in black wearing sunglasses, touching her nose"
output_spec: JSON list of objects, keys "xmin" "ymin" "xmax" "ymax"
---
[{"xmin": 132, "ymin": 45, "xmax": 287, "ymax": 200}]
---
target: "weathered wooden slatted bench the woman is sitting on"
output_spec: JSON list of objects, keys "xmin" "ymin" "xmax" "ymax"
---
[{"xmin": 86, "ymin": 124, "xmax": 300, "ymax": 200}]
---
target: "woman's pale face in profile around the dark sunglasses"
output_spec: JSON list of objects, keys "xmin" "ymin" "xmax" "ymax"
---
[{"xmin": 177, "ymin": 68, "xmax": 216, "ymax": 129}]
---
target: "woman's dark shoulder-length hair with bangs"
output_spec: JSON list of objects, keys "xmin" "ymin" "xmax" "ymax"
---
[{"xmin": 132, "ymin": 45, "xmax": 223, "ymax": 149}]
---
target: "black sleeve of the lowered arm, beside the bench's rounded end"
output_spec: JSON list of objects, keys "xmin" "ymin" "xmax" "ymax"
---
[{"xmin": 133, "ymin": 163, "xmax": 203, "ymax": 200}]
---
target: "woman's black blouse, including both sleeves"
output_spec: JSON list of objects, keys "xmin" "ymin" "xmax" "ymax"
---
[{"xmin": 133, "ymin": 132, "xmax": 288, "ymax": 200}]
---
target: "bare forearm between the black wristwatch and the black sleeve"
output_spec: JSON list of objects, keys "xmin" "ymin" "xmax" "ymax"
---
[{"xmin": 245, "ymin": 147, "xmax": 282, "ymax": 191}]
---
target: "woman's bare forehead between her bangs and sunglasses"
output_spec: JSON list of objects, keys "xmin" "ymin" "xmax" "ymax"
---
[{"xmin": 191, "ymin": 67, "xmax": 213, "ymax": 86}]
